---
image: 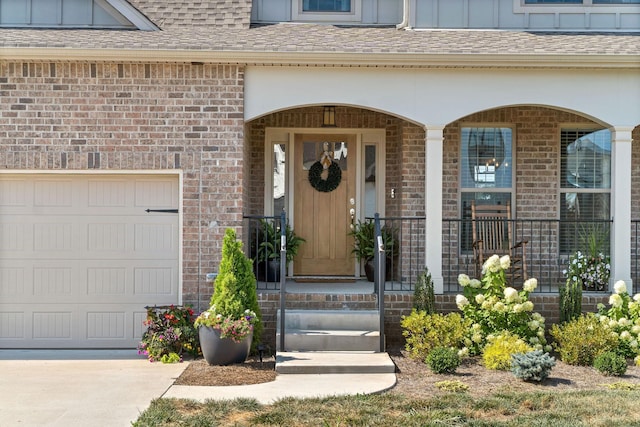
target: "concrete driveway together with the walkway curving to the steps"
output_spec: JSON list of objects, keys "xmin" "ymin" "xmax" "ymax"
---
[{"xmin": 0, "ymin": 350, "xmax": 396, "ymax": 427}]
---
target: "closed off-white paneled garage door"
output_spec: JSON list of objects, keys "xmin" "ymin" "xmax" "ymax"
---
[{"xmin": 0, "ymin": 174, "xmax": 179, "ymax": 348}]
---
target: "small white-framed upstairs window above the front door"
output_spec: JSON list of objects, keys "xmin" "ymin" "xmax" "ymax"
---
[{"xmin": 291, "ymin": 0, "xmax": 362, "ymax": 22}]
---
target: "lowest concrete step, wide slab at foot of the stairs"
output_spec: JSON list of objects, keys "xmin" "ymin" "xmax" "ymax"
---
[{"xmin": 276, "ymin": 351, "xmax": 396, "ymax": 374}]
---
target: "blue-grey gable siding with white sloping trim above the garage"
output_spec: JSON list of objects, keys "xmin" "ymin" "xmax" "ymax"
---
[{"xmin": 0, "ymin": 0, "xmax": 157, "ymax": 30}]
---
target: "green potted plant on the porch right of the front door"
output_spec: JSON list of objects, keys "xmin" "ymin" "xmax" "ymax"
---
[{"xmin": 349, "ymin": 220, "xmax": 396, "ymax": 282}]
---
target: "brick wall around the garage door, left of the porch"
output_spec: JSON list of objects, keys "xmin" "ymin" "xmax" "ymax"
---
[{"xmin": 0, "ymin": 62, "xmax": 246, "ymax": 305}]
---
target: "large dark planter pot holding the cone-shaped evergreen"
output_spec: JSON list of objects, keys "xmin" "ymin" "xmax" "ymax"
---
[{"xmin": 198, "ymin": 326, "xmax": 253, "ymax": 365}]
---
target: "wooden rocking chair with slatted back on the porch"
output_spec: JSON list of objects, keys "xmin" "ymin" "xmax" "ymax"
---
[{"xmin": 471, "ymin": 201, "xmax": 528, "ymax": 286}]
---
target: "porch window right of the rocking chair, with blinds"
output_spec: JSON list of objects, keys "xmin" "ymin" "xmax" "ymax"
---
[{"xmin": 560, "ymin": 129, "xmax": 611, "ymax": 254}]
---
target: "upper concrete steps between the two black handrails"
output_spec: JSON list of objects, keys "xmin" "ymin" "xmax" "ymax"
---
[{"xmin": 276, "ymin": 310, "xmax": 380, "ymax": 352}]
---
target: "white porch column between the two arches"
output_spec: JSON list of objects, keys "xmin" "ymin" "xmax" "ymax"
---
[{"xmin": 424, "ymin": 125, "xmax": 444, "ymax": 294}]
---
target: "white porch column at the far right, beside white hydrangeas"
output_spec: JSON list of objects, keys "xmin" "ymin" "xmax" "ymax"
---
[{"xmin": 610, "ymin": 126, "xmax": 633, "ymax": 294}]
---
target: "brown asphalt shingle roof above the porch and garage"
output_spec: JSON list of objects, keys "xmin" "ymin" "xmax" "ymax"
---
[{"xmin": 0, "ymin": 0, "xmax": 640, "ymax": 65}]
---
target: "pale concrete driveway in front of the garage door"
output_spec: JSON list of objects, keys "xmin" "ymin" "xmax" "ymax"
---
[{"xmin": 0, "ymin": 350, "xmax": 187, "ymax": 427}]
